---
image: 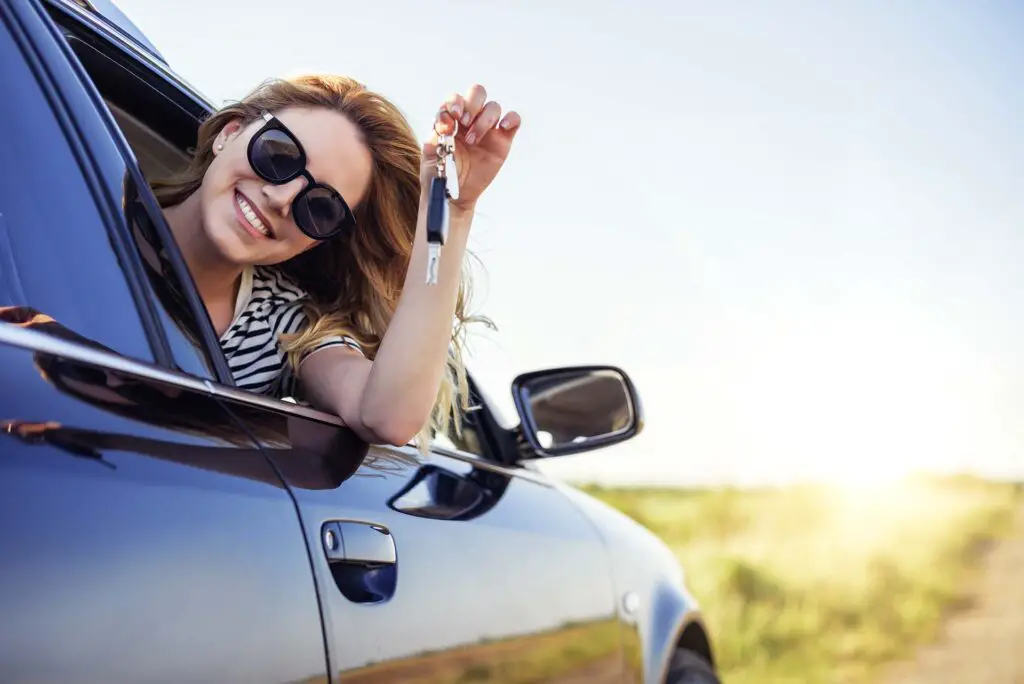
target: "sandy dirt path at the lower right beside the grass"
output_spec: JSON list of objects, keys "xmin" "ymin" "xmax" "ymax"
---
[{"xmin": 881, "ymin": 508, "xmax": 1024, "ymax": 684}]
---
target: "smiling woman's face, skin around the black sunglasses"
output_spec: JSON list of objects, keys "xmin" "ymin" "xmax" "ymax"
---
[{"xmin": 199, "ymin": 108, "xmax": 372, "ymax": 265}]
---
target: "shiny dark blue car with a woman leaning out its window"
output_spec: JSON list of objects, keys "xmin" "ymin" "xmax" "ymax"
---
[{"xmin": 0, "ymin": 0, "xmax": 718, "ymax": 684}]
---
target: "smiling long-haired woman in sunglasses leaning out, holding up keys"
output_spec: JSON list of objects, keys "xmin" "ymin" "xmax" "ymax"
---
[{"xmin": 154, "ymin": 76, "xmax": 521, "ymax": 448}]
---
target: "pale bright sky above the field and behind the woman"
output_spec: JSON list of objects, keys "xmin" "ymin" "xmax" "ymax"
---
[{"xmin": 108, "ymin": 0, "xmax": 1024, "ymax": 485}]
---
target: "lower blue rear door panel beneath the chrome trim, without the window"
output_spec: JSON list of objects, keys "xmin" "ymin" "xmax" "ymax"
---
[{"xmin": 0, "ymin": 325, "xmax": 326, "ymax": 682}]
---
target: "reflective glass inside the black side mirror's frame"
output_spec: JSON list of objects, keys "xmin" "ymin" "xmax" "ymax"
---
[{"xmin": 520, "ymin": 369, "xmax": 636, "ymax": 453}]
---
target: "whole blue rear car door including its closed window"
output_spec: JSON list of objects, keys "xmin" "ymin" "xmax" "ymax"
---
[{"xmin": 0, "ymin": 0, "xmax": 327, "ymax": 683}]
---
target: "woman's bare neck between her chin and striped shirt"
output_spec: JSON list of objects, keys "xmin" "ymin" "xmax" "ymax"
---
[{"xmin": 164, "ymin": 193, "xmax": 243, "ymax": 309}]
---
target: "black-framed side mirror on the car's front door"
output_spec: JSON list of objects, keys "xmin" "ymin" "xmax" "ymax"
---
[{"xmin": 512, "ymin": 366, "xmax": 643, "ymax": 458}]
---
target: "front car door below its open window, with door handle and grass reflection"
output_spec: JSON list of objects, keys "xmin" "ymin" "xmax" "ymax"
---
[{"xmin": 219, "ymin": 395, "xmax": 625, "ymax": 684}]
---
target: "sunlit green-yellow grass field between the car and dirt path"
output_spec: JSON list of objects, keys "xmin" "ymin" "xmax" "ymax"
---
[{"xmin": 585, "ymin": 477, "xmax": 1024, "ymax": 684}]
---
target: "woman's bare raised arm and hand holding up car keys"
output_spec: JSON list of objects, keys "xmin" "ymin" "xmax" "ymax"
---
[{"xmin": 299, "ymin": 86, "xmax": 520, "ymax": 444}]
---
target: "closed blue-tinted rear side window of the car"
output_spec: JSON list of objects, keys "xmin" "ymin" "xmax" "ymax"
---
[{"xmin": 0, "ymin": 18, "xmax": 154, "ymax": 361}]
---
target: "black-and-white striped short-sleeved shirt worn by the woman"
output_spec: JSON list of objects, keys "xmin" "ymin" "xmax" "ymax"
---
[{"xmin": 220, "ymin": 266, "xmax": 361, "ymax": 398}]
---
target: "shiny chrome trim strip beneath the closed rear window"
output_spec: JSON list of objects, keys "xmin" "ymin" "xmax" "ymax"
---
[{"xmin": 0, "ymin": 324, "xmax": 209, "ymax": 394}]
